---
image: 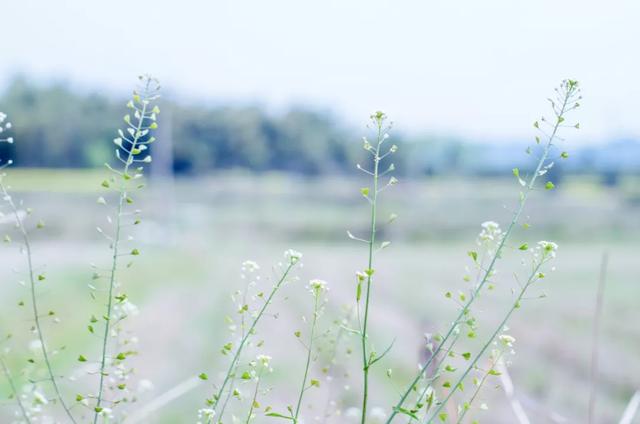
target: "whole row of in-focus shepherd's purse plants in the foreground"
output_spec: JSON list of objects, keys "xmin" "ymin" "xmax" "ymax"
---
[{"xmin": 0, "ymin": 76, "xmax": 581, "ymax": 424}]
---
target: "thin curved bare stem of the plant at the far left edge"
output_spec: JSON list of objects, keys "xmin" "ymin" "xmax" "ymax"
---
[{"xmin": 0, "ymin": 182, "xmax": 76, "ymax": 423}]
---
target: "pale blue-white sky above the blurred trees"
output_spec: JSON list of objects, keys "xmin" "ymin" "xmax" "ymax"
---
[{"xmin": 0, "ymin": 0, "xmax": 640, "ymax": 142}]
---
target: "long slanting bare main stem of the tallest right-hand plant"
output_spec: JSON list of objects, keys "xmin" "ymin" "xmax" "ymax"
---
[{"xmin": 386, "ymin": 83, "xmax": 575, "ymax": 424}]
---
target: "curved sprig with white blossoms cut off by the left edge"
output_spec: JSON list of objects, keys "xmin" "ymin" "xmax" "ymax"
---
[{"xmin": 0, "ymin": 113, "xmax": 76, "ymax": 423}]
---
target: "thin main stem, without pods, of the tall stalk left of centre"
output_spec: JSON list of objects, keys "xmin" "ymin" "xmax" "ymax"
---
[{"xmin": 93, "ymin": 101, "xmax": 148, "ymax": 424}]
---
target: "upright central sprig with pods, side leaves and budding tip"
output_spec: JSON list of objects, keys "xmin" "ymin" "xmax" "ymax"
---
[{"xmin": 347, "ymin": 111, "xmax": 398, "ymax": 424}]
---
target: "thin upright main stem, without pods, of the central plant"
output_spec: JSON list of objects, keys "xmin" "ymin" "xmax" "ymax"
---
[{"xmin": 360, "ymin": 120, "xmax": 383, "ymax": 424}]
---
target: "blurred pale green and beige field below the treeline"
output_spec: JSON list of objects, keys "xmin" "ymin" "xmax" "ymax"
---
[{"xmin": 0, "ymin": 169, "xmax": 640, "ymax": 423}]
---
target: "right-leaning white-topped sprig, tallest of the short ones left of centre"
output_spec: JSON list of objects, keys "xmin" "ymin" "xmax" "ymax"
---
[{"xmin": 205, "ymin": 250, "xmax": 302, "ymax": 424}]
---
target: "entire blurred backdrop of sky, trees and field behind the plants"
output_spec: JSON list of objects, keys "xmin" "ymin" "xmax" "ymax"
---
[{"xmin": 0, "ymin": 0, "xmax": 640, "ymax": 423}]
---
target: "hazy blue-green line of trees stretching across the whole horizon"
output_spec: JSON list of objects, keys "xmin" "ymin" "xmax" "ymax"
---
[{"xmin": 0, "ymin": 77, "xmax": 640, "ymax": 176}]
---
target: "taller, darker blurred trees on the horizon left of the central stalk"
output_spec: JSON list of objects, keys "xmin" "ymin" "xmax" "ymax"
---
[{"xmin": 0, "ymin": 77, "xmax": 376, "ymax": 174}]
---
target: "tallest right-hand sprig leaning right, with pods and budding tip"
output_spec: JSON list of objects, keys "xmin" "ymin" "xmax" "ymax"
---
[{"xmin": 386, "ymin": 80, "xmax": 581, "ymax": 424}]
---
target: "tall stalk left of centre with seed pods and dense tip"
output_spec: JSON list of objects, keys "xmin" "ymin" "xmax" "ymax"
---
[{"xmin": 89, "ymin": 76, "xmax": 160, "ymax": 423}]
